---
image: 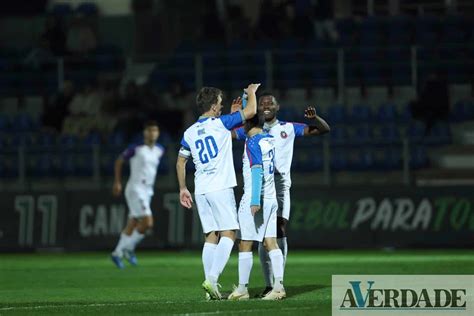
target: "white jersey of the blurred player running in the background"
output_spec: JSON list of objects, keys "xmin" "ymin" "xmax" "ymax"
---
[{"xmin": 122, "ymin": 144, "xmax": 165, "ymax": 194}]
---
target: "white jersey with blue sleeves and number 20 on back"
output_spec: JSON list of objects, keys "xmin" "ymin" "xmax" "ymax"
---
[{"xmin": 179, "ymin": 111, "xmax": 245, "ymax": 194}]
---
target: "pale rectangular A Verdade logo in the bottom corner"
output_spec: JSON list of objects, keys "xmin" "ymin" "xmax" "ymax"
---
[{"xmin": 332, "ymin": 275, "xmax": 474, "ymax": 316}]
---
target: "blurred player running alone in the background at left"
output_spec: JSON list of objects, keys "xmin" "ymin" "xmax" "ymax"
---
[{"xmin": 111, "ymin": 121, "xmax": 165, "ymax": 269}]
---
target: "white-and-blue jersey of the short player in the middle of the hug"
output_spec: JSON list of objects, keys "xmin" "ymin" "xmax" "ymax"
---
[{"xmin": 242, "ymin": 133, "xmax": 276, "ymax": 199}]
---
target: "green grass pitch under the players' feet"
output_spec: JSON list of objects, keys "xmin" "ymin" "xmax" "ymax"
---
[{"xmin": 0, "ymin": 250, "xmax": 474, "ymax": 316}]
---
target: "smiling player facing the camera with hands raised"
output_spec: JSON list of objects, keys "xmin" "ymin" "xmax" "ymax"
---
[{"xmin": 233, "ymin": 92, "xmax": 330, "ymax": 296}]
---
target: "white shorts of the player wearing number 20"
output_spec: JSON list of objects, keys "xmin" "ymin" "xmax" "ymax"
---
[{"xmin": 195, "ymin": 188, "xmax": 239, "ymax": 234}]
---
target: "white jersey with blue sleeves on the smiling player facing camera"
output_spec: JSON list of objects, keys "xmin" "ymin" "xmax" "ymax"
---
[{"xmin": 235, "ymin": 120, "xmax": 308, "ymax": 186}]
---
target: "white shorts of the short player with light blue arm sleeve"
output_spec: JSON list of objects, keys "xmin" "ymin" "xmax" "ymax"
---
[{"xmin": 238, "ymin": 194, "xmax": 278, "ymax": 242}]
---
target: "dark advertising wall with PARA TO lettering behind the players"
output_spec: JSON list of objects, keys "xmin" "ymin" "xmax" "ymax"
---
[{"xmin": 0, "ymin": 186, "xmax": 474, "ymax": 252}]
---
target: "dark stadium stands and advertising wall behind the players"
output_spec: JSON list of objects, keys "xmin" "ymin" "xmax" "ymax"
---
[{"xmin": 0, "ymin": 0, "xmax": 474, "ymax": 252}]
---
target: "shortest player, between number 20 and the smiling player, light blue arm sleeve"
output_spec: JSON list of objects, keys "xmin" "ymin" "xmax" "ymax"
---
[{"xmin": 228, "ymin": 111, "xmax": 286, "ymax": 301}]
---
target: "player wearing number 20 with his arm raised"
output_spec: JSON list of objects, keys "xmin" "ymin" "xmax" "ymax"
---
[{"xmin": 176, "ymin": 84, "xmax": 259, "ymax": 299}]
